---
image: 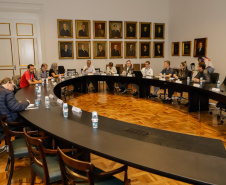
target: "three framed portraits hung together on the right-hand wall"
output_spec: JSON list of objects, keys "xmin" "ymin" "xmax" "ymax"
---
[{"xmin": 172, "ymin": 38, "xmax": 207, "ymax": 57}]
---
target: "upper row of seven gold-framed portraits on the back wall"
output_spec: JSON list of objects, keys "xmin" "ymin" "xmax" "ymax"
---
[{"xmin": 57, "ymin": 19, "xmax": 165, "ymax": 39}]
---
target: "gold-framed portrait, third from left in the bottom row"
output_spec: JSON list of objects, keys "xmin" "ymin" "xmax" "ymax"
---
[{"xmin": 93, "ymin": 41, "xmax": 108, "ymax": 59}]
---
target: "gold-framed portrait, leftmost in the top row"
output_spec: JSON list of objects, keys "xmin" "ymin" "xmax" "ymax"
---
[{"xmin": 57, "ymin": 19, "xmax": 73, "ymax": 38}]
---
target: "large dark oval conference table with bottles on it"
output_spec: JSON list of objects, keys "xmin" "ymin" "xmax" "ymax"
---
[{"xmin": 16, "ymin": 75, "xmax": 226, "ymax": 185}]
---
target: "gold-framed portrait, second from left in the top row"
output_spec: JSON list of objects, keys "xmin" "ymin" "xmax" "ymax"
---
[{"xmin": 75, "ymin": 20, "xmax": 91, "ymax": 39}]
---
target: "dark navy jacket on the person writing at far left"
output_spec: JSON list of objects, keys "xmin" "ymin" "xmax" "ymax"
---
[{"xmin": 0, "ymin": 85, "xmax": 29, "ymax": 122}]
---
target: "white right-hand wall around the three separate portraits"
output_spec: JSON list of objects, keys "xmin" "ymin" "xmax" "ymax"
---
[{"xmin": 168, "ymin": 0, "xmax": 226, "ymax": 81}]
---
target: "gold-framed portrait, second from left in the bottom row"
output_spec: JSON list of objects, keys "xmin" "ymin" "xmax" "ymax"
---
[{"xmin": 76, "ymin": 41, "xmax": 91, "ymax": 59}]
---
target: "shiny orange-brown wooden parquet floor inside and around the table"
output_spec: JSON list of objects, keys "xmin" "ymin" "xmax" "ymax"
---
[{"xmin": 0, "ymin": 84, "xmax": 226, "ymax": 185}]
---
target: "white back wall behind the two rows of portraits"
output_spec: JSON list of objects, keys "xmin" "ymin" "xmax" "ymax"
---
[{"xmin": 40, "ymin": 0, "xmax": 169, "ymax": 74}]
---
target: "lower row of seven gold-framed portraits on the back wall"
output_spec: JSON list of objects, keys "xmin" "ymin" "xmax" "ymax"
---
[{"xmin": 58, "ymin": 41, "xmax": 165, "ymax": 59}]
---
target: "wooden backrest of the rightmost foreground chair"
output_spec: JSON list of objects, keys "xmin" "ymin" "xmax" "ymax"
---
[{"xmin": 57, "ymin": 147, "xmax": 94, "ymax": 185}]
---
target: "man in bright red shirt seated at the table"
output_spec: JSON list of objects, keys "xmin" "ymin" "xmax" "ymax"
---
[{"xmin": 20, "ymin": 64, "xmax": 42, "ymax": 88}]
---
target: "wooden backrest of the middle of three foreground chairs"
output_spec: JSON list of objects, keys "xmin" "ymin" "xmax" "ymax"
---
[{"xmin": 24, "ymin": 128, "xmax": 49, "ymax": 182}]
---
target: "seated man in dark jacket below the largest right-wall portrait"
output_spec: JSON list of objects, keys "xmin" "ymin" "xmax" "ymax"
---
[{"xmin": 193, "ymin": 62, "xmax": 210, "ymax": 82}]
